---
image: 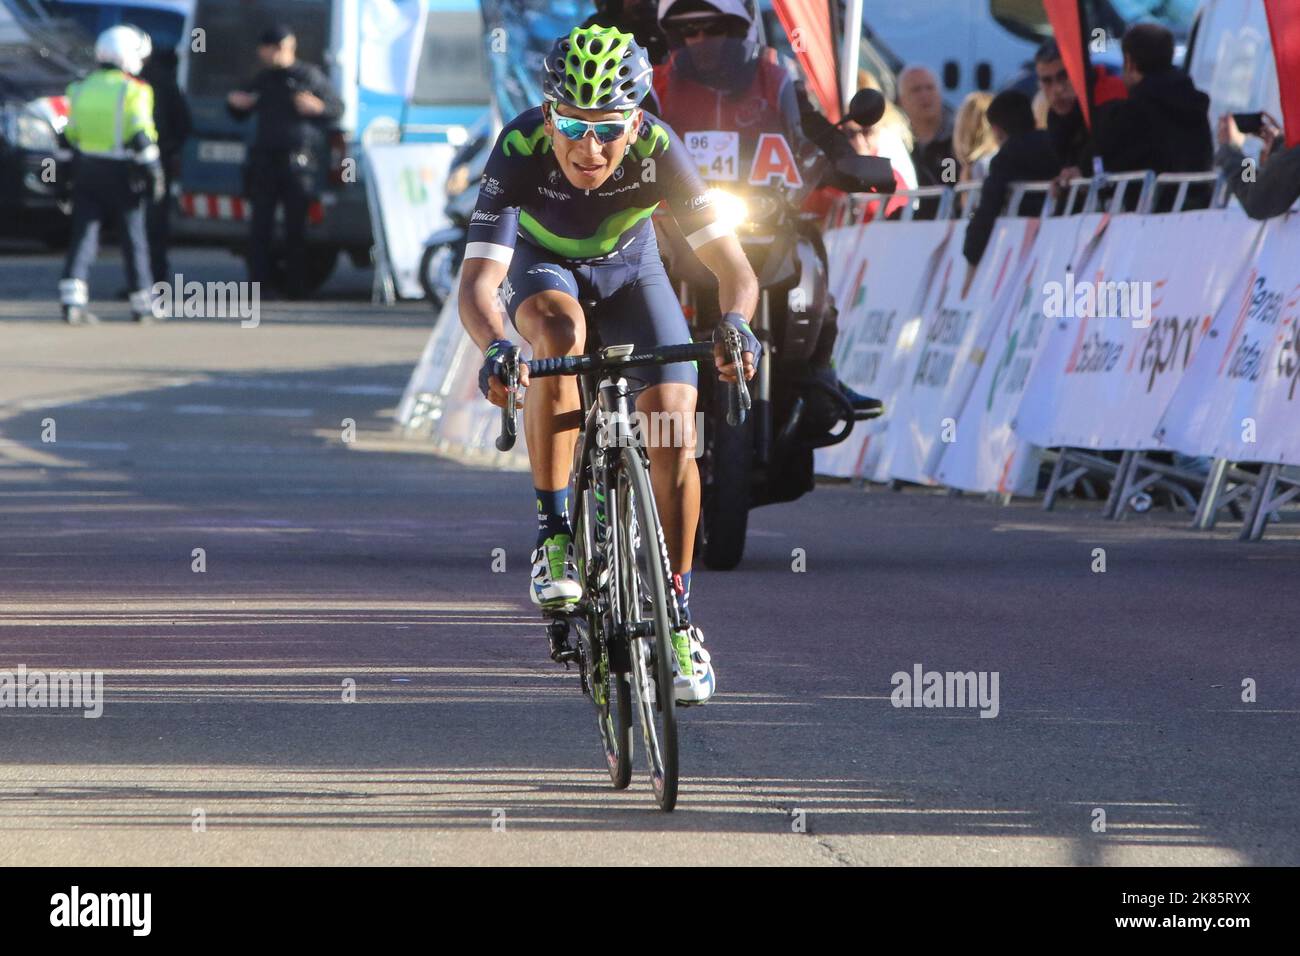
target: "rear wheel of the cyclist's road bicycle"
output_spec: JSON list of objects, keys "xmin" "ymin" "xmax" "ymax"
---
[{"xmin": 573, "ymin": 468, "xmax": 633, "ymax": 790}]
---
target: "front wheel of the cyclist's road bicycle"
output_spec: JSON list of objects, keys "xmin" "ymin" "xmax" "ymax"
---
[{"xmin": 608, "ymin": 447, "xmax": 677, "ymax": 812}]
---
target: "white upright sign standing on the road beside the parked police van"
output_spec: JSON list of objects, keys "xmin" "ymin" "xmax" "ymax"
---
[{"xmin": 365, "ymin": 143, "xmax": 455, "ymax": 299}]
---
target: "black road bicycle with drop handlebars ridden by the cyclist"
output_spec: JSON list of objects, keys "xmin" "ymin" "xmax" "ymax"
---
[{"xmin": 497, "ymin": 329, "xmax": 750, "ymax": 812}]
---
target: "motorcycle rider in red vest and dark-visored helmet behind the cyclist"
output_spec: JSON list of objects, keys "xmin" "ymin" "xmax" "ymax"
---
[{"xmin": 655, "ymin": 0, "xmax": 881, "ymax": 428}]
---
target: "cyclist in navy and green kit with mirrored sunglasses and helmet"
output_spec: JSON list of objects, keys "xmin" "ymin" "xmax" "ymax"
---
[{"xmin": 460, "ymin": 26, "xmax": 762, "ymax": 704}]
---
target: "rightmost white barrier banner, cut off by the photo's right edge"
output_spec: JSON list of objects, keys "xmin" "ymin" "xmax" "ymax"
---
[{"xmin": 1160, "ymin": 216, "xmax": 1300, "ymax": 464}]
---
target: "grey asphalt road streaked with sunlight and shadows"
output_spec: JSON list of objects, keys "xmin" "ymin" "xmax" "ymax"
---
[{"xmin": 0, "ymin": 240, "xmax": 1300, "ymax": 865}]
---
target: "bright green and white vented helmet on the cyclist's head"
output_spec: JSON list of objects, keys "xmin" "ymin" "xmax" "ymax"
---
[{"xmin": 542, "ymin": 26, "xmax": 653, "ymax": 109}]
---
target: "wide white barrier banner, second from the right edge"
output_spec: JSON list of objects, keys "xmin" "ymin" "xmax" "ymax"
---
[{"xmin": 1015, "ymin": 209, "xmax": 1261, "ymax": 450}]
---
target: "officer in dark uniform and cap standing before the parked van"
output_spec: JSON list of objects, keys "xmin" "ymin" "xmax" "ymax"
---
[{"xmin": 226, "ymin": 26, "xmax": 343, "ymax": 298}]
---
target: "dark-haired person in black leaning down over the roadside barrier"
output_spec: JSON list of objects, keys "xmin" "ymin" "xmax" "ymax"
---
[{"xmin": 962, "ymin": 90, "xmax": 1061, "ymax": 267}]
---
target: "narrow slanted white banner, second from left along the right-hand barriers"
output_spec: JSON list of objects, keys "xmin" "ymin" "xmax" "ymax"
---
[{"xmin": 874, "ymin": 219, "xmax": 1030, "ymax": 484}]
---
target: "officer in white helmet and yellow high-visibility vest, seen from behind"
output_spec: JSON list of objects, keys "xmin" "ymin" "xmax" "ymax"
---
[{"xmin": 59, "ymin": 26, "xmax": 164, "ymax": 325}]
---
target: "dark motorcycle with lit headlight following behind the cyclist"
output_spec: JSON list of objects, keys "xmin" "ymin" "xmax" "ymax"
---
[{"xmin": 675, "ymin": 90, "xmax": 894, "ymax": 570}]
